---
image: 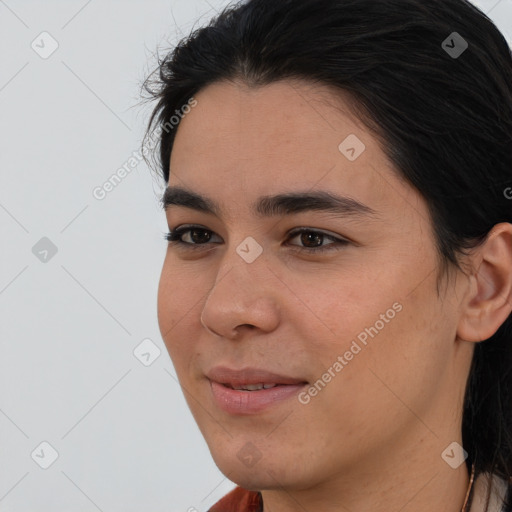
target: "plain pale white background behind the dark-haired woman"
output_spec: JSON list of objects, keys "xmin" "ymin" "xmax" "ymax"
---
[{"xmin": 0, "ymin": 0, "xmax": 512, "ymax": 512}]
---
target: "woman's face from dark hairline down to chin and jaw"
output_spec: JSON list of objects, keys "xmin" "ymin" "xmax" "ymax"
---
[{"xmin": 158, "ymin": 81, "xmax": 472, "ymax": 489}]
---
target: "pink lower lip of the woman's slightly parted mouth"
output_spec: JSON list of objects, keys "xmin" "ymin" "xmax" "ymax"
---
[{"xmin": 210, "ymin": 381, "xmax": 306, "ymax": 414}]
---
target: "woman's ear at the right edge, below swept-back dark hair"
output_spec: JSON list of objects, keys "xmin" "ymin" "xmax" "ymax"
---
[{"xmin": 457, "ymin": 222, "xmax": 512, "ymax": 341}]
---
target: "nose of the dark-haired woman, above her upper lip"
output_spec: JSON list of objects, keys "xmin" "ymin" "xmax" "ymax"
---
[{"xmin": 200, "ymin": 251, "xmax": 280, "ymax": 339}]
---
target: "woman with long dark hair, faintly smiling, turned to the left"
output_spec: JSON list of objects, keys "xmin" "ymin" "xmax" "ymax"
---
[{"xmin": 142, "ymin": 0, "xmax": 512, "ymax": 512}]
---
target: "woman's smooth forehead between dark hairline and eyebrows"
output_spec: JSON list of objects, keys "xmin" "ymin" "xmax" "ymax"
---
[{"xmin": 169, "ymin": 81, "xmax": 424, "ymax": 222}]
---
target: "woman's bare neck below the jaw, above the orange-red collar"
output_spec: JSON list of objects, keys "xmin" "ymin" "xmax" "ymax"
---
[{"xmin": 261, "ymin": 427, "xmax": 470, "ymax": 512}]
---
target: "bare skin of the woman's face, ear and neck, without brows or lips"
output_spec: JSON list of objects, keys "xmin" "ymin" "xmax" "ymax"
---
[{"xmin": 158, "ymin": 81, "xmax": 512, "ymax": 512}]
